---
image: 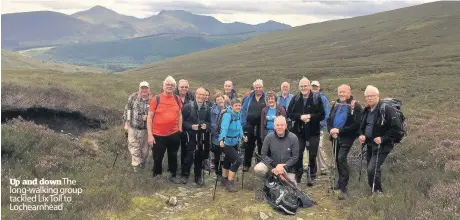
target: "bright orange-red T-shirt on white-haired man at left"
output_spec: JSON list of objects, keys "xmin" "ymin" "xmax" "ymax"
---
[{"xmin": 149, "ymin": 93, "xmax": 182, "ymax": 136}]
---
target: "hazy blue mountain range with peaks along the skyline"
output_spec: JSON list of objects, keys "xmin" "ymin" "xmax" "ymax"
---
[{"xmin": 2, "ymin": 6, "xmax": 290, "ymax": 50}]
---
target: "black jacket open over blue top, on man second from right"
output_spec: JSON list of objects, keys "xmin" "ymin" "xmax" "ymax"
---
[{"xmin": 327, "ymin": 96, "xmax": 363, "ymax": 146}]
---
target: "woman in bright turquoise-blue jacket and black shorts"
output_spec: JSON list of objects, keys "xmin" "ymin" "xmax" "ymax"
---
[{"xmin": 218, "ymin": 99, "xmax": 248, "ymax": 192}]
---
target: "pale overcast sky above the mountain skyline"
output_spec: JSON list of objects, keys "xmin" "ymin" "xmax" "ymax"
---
[{"xmin": 2, "ymin": 0, "xmax": 433, "ymax": 26}]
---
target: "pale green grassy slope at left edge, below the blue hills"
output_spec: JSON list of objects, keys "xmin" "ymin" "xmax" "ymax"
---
[{"xmin": 2, "ymin": 50, "xmax": 107, "ymax": 72}]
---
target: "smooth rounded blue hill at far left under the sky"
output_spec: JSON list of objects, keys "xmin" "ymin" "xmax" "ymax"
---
[{"xmin": 2, "ymin": 11, "xmax": 122, "ymax": 49}]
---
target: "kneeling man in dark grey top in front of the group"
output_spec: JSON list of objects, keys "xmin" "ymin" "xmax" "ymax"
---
[{"xmin": 254, "ymin": 116, "xmax": 300, "ymax": 200}]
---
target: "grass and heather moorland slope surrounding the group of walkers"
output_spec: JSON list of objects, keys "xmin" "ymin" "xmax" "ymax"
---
[{"xmin": 2, "ymin": 2, "xmax": 460, "ymax": 220}]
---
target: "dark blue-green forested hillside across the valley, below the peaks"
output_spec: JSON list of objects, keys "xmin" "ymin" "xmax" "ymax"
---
[{"xmin": 20, "ymin": 32, "xmax": 261, "ymax": 72}]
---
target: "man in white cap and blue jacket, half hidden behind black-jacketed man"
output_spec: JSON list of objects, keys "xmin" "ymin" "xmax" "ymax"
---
[{"xmin": 311, "ymin": 81, "xmax": 331, "ymax": 175}]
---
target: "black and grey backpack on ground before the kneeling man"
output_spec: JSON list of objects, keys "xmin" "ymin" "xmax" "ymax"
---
[{"xmin": 263, "ymin": 175, "xmax": 301, "ymax": 215}]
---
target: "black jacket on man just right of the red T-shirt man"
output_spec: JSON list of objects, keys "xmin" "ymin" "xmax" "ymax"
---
[{"xmin": 182, "ymin": 101, "xmax": 211, "ymax": 140}]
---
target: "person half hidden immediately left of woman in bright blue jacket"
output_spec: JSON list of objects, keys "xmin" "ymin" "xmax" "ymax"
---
[{"xmin": 211, "ymin": 92, "xmax": 227, "ymax": 181}]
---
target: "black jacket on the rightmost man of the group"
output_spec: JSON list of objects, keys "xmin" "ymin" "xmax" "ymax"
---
[{"xmin": 359, "ymin": 101, "xmax": 401, "ymax": 146}]
